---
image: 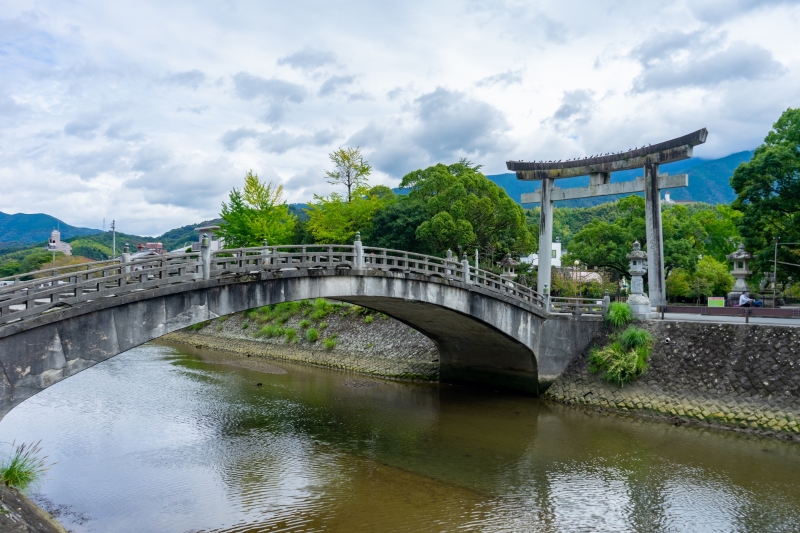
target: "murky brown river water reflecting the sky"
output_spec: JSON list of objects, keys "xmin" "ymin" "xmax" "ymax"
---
[{"xmin": 0, "ymin": 344, "xmax": 800, "ymax": 533}]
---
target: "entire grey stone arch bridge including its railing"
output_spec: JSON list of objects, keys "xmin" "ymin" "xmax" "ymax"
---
[{"xmin": 0, "ymin": 240, "xmax": 602, "ymax": 417}]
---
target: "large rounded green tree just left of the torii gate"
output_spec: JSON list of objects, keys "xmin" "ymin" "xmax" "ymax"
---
[{"xmin": 400, "ymin": 160, "xmax": 534, "ymax": 259}]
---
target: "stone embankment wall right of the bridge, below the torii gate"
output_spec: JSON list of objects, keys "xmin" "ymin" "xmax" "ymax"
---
[{"xmin": 545, "ymin": 321, "xmax": 800, "ymax": 440}]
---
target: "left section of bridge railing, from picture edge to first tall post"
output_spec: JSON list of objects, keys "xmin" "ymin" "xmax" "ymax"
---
[{"xmin": 0, "ymin": 254, "xmax": 203, "ymax": 324}]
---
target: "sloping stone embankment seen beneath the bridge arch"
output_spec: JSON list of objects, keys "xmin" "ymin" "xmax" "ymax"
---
[{"xmin": 162, "ymin": 305, "xmax": 439, "ymax": 381}]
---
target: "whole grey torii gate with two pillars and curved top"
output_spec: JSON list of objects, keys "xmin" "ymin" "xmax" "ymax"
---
[{"xmin": 506, "ymin": 128, "xmax": 708, "ymax": 306}]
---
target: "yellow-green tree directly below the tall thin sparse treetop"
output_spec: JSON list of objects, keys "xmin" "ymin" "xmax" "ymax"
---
[{"xmin": 306, "ymin": 185, "xmax": 395, "ymax": 244}]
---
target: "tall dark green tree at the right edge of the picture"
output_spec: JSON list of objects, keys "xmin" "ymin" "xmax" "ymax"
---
[{"xmin": 731, "ymin": 108, "xmax": 800, "ymax": 280}]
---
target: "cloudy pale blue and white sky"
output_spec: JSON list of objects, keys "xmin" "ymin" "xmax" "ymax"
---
[{"xmin": 0, "ymin": 0, "xmax": 800, "ymax": 234}]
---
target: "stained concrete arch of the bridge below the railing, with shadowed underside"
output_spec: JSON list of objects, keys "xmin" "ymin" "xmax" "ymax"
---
[{"xmin": 0, "ymin": 268, "xmax": 560, "ymax": 416}]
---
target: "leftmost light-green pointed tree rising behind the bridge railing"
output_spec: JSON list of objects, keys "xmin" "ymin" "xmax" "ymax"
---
[{"xmin": 220, "ymin": 170, "xmax": 296, "ymax": 248}]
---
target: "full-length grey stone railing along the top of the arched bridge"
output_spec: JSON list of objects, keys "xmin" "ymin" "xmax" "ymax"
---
[{"xmin": 0, "ymin": 240, "xmax": 548, "ymax": 324}]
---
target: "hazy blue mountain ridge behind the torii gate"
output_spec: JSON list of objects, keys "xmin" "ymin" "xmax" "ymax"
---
[{"xmin": 486, "ymin": 151, "xmax": 753, "ymax": 207}]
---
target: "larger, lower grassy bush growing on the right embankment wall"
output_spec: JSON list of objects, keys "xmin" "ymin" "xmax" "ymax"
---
[{"xmin": 589, "ymin": 327, "xmax": 653, "ymax": 387}]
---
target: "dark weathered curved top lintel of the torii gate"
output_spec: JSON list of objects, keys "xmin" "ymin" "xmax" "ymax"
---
[{"xmin": 506, "ymin": 128, "xmax": 708, "ymax": 180}]
